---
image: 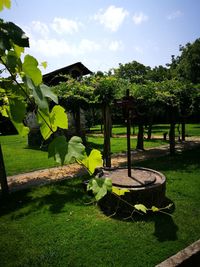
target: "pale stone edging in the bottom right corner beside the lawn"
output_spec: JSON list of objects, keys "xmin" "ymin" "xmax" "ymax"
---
[{"xmin": 155, "ymin": 239, "xmax": 200, "ymax": 267}]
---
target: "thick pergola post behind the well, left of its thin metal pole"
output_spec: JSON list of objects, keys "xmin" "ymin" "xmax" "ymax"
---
[{"xmin": 103, "ymin": 105, "xmax": 111, "ymax": 168}]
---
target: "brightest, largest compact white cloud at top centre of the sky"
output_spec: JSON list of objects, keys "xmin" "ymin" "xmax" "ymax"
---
[{"xmin": 94, "ymin": 6, "xmax": 128, "ymax": 32}]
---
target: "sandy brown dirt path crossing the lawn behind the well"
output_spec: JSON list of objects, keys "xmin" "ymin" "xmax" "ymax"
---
[{"xmin": 8, "ymin": 137, "xmax": 200, "ymax": 191}]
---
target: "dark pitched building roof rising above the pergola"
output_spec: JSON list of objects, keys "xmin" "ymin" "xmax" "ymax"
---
[{"xmin": 43, "ymin": 62, "xmax": 92, "ymax": 86}]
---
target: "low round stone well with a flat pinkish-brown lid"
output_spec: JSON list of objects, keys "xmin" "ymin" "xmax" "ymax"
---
[{"xmin": 100, "ymin": 167, "xmax": 166, "ymax": 216}]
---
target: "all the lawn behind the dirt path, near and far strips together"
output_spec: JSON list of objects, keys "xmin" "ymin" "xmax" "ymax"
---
[{"xmin": 0, "ymin": 124, "xmax": 200, "ymax": 178}]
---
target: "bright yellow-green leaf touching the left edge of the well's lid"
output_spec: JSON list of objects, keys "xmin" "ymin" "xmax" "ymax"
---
[{"xmin": 82, "ymin": 149, "xmax": 103, "ymax": 174}]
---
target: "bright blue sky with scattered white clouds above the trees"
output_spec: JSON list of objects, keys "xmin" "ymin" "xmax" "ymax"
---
[{"xmin": 0, "ymin": 0, "xmax": 200, "ymax": 74}]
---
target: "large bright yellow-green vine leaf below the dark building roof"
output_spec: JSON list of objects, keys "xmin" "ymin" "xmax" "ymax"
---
[{"xmin": 50, "ymin": 105, "xmax": 68, "ymax": 130}]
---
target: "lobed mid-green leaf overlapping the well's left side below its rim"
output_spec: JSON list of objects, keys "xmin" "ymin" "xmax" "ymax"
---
[{"xmin": 87, "ymin": 178, "xmax": 112, "ymax": 201}]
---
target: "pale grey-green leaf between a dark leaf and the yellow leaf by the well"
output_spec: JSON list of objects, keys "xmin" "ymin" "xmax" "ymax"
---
[{"xmin": 65, "ymin": 136, "xmax": 85, "ymax": 163}]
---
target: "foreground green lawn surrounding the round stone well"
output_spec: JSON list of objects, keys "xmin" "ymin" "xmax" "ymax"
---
[{"xmin": 0, "ymin": 148, "xmax": 200, "ymax": 267}]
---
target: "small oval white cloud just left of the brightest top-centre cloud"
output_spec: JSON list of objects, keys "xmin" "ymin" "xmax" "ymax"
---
[{"xmin": 51, "ymin": 17, "xmax": 82, "ymax": 34}]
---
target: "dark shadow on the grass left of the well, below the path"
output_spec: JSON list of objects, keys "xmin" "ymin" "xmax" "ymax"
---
[{"xmin": 0, "ymin": 177, "xmax": 90, "ymax": 219}]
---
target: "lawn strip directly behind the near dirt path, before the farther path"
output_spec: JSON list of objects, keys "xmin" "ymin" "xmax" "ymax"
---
[{"xmin": 0, "ymin": 135, "xmax": 166, "ymax": 175}]
